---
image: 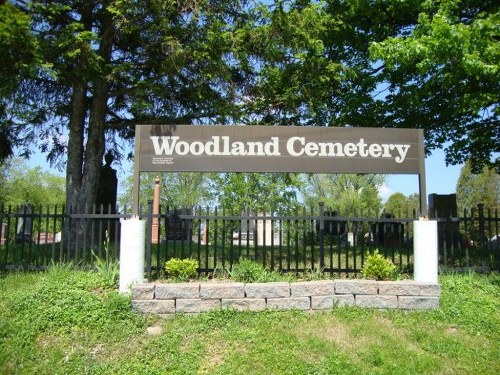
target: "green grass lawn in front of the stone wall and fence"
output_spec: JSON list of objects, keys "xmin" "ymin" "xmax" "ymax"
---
[{"xmin": 0, "ymin": 268, "xmax": 500, "ymax": 375}]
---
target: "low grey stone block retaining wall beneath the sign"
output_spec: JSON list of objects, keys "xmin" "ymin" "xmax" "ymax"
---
[{"xmin": 132, "ymin": 280, "xmax": 440, "ymax": 315}]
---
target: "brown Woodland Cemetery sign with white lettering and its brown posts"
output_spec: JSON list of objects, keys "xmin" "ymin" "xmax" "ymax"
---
[{"xmin": 134, "ymin": 125, "xmax": 426, "ymax": 212}]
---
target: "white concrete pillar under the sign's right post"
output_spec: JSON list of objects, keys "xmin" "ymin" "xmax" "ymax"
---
[{"xmin": 413, "ymin": 220, "xmax": 438, "ymax": 283}]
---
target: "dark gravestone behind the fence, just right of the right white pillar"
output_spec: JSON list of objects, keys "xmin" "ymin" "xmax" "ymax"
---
[{"xmin": 429, "ymin": 194, "xmax": 459, "ymax": 248}]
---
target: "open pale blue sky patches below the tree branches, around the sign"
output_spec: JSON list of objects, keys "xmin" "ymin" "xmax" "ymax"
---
[{"xmin": 22, "ymin": 144, "xmax": 462, "ymax": 201}]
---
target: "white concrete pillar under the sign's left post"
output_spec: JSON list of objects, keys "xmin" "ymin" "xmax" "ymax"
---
[{"xmin": 119, "ymin": 217, "xmax": 146, "ymax": 293}]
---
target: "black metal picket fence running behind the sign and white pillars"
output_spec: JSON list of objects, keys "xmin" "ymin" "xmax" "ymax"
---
[{"xmin": 0, "ymin": 205, "xmax": 500, "ymax": 279}]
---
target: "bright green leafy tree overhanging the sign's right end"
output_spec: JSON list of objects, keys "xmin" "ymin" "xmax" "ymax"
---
[{"xmin": 371, "ymin": 0, "xmax": 500, "ymax": 172}]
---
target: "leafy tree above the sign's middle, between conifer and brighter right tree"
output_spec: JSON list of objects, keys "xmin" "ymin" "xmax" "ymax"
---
[{"xmin": 241, "ymin": 0, "xmax": 419, "ymax": 127}]
